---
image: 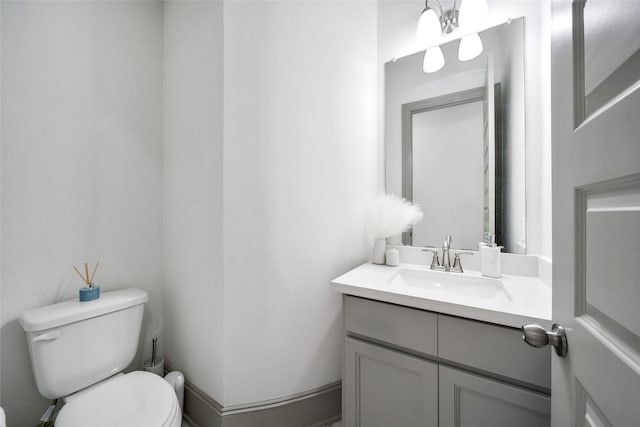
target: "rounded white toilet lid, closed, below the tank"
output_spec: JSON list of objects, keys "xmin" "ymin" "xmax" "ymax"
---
[{"xmin": 55, "ymin": 371, "xmax": 182, "ymax": 427}]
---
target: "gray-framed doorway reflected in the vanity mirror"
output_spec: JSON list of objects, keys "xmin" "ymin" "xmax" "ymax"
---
[{"xmin": 402, "ymin": 83, "xmax": 504, "ymax": 248}]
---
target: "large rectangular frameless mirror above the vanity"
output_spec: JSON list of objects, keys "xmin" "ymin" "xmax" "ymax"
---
[{"xmin": 385, "ymin": 18, "xmax": 526, "ymax": 254}]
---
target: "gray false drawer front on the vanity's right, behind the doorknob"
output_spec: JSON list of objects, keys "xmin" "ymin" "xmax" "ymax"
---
[{"xmin": 438, "ymin": 314, "xmax": 551, "ymax": 389}]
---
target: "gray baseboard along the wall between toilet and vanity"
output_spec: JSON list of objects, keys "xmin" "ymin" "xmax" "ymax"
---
[{"xmin": 166, "ymin": 367, "xmax": 342, "ymax": 427}]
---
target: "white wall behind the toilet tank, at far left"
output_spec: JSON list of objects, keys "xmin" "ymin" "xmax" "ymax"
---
[{"xmin": 0, "ymin": 1, "xmax": 162, "ymax": 426}]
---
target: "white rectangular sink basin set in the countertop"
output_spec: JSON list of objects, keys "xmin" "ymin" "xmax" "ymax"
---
[{"xmin": 389, "ymin": 269, "xmax": 511, "ymax": 299}]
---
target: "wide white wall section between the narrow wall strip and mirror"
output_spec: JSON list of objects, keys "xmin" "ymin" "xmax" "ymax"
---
[{"xmin": 224, "ymin": 1, "xmax": 377, "ymax": 404}]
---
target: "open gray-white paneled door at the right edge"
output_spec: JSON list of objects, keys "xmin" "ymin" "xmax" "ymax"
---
[{"xmin": 551, "ymin": 0, "xmax": 640, "ymax": 427}]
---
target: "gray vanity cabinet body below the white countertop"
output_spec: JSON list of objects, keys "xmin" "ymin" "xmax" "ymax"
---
[{"xmin": 342, "ymin": 295, "xmax": 551, "ymax": 427}]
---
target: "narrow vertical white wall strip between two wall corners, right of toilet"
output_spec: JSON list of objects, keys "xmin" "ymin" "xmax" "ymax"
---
[{"xmin": 163, "ymin": 1, "xmax": 224, "ymax": 401}]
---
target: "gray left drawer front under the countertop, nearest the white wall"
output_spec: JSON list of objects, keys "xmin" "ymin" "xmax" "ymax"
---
[{"xmin": 344, "ymin": 296, "xmax": 438, "ymax": 356}]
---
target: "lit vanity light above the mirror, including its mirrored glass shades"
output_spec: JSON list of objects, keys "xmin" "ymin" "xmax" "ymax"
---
[{"xmin": 416, "ymin": 0, "xmax": 488, "ymax": 73}]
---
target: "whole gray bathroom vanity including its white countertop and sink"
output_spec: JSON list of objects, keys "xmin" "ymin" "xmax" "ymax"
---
[{"xmin": 332, "ymin": 264, "xmax": 551, "ymax": 427}]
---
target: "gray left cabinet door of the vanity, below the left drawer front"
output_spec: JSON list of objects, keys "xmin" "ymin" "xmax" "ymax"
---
[{"xmin": 343, "ymin": 338, "xmax": 438, "ymax": 427}]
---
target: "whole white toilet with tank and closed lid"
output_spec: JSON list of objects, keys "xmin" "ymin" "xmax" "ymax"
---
[{"xmin": 20, "ymin": 288, "xmax": 182, "ymax": 427}]
